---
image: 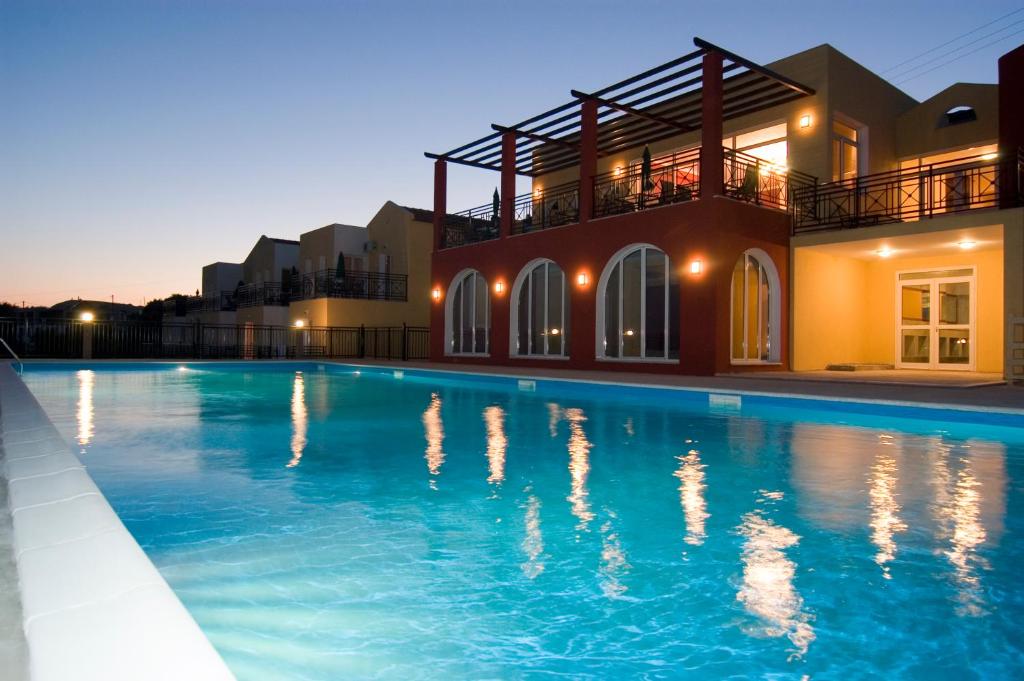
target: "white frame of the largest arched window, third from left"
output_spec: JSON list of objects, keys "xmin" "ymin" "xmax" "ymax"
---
[{"xmin": 594, "ymin": 244, "xmax": 682, "ymax": 365}]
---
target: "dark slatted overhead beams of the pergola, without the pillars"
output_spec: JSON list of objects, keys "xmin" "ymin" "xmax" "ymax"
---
[{"xmin": 426, "ymin": 38, "xmax": 814, "ymax": 177}]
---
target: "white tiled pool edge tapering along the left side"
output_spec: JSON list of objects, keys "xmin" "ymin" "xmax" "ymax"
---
[{"xmin": 0, "ymin": 363, "xmax": 234, "ymax": 681}]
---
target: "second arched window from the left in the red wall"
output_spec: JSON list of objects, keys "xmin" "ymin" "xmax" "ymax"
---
[{"xmin": 511, "ymin": 260, "xmax": 569, "ymax": 357}]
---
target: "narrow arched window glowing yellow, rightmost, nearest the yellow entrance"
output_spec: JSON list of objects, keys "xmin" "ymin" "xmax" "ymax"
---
[{"xmin": 731, "ymin": 248, "xmax": 780, "ymax": 364}]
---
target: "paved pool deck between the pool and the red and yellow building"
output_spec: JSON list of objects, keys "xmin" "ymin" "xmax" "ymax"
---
[{"xmin": 339, "ymin": 359, "xmax": 1024, "ymax": 415}]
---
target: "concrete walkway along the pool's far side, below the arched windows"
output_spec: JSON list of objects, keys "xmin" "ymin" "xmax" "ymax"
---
[{"xmin": 335, "ymin": 359, "xmax": 1024, "ymax": 416}]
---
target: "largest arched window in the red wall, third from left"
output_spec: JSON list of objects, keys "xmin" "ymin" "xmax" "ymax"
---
[{"xmin": 597, "ymin": 245, "xmax": 679, "ymax": 359}]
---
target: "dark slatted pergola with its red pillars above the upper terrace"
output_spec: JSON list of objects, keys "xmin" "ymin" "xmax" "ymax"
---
[{"xmin": 426, "ymin": 38, "xmax": 814, "ymax": 241}]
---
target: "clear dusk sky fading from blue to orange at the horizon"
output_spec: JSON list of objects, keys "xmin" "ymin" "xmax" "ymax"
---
[{"xmin": 0, "ymin": 0, "xmax": 1024, "ymax": 304}]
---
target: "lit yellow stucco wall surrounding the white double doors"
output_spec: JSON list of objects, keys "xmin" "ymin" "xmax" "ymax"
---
[{"xmin": 793, "ymin": 248, "xmax": 1005, "ymax": 373}]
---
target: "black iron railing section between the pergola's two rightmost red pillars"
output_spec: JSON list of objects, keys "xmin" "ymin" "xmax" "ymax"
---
[{"xmin": 594, "ymin": 148, "xmax": 700, "ymax": 217}]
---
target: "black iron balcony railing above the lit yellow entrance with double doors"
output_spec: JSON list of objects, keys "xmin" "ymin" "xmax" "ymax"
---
[{"xmin": 793, "ymin": 152, "xmax": 1024, "ymax": 232}]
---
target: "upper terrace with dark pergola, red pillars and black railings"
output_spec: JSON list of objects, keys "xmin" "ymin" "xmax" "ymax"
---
[{"xmin": 426, "ymin": 38, "xmax": 816, "ymax": 249}]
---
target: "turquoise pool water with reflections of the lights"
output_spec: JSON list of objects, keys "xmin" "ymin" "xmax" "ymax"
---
[{"xmin": 18, "ymin": 365, "xmax": 1024, "ymax": 681}]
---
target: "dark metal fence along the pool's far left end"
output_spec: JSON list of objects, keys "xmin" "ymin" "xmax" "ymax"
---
[{"xmin": 0, "ymin": 317, "xmax": 430, "ymax": 360}]
